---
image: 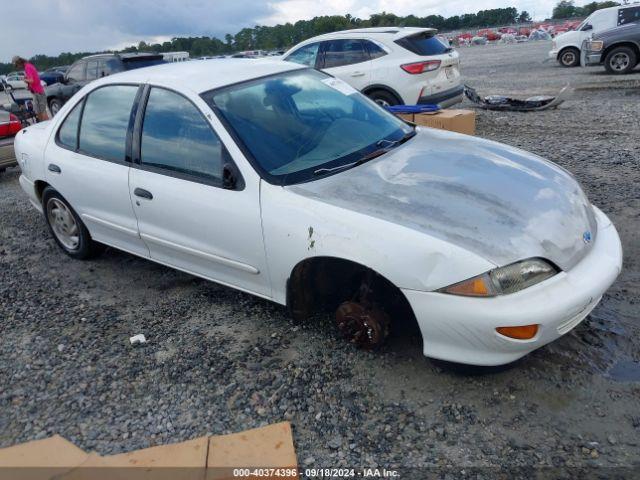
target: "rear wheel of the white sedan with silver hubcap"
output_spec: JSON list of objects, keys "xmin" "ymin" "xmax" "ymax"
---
[{"xmin": 42, "ymin": 187, "xmax": 104, "ymax": 260}]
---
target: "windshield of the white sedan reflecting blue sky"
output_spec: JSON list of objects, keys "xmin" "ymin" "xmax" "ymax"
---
[{"xmin": 202, "ymin": 69, "xmax": 413, "ymax": 185}]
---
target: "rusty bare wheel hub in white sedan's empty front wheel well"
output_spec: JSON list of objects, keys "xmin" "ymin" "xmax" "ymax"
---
[{"xmin": 336, "ymin": 301, "xmax": 391, "ymax": 350}]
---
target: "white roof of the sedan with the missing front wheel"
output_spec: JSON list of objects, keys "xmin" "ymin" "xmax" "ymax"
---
[{"xmin": 92, "ymin": 58, "xmax": 308, "ymax": 93}]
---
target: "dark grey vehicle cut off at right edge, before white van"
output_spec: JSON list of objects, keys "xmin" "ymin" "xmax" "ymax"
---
[{"xmin": 582, "ymin": 20, "xmax": 640, "ymax": 74}]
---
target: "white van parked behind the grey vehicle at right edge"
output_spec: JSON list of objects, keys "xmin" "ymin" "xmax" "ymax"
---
[{"xmin": 549, "ymin": 3, "xmax": 640, "ymax": 67}]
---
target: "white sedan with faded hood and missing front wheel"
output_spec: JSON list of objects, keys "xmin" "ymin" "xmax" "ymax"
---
[{"xmin": 15, "ymin": 60, "xmax": 622, "ymax": 365}]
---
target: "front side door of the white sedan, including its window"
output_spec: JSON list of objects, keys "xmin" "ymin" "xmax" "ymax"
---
[{"xmin": 130, "ymin": 87, "xmax": 271, "ymax": 297}]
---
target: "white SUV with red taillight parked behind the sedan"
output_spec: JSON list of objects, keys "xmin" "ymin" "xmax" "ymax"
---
[{"xmin": 283, "ymin": 27, "xmax": 464, "ymax": 108}]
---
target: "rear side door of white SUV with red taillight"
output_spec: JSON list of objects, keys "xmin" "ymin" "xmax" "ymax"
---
[{"xmin": 321, "ymin": 39, "xmax": 371, "ymax": 90}]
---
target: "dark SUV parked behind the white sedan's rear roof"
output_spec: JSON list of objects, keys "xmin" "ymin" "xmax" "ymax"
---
[{"xmin": 45, "ymin": 53, "xmax": 166, "ymax": 116}]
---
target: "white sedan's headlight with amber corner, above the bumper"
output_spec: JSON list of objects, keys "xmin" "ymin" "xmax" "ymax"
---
[{"xmin": 438, "ymin": 258, "xmax": 558, "ymax": 297}]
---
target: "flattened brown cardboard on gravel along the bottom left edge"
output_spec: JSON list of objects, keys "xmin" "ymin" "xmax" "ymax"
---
[{"xmin": 0, "ymin": 422, "xmax": 298, "ymax": 480}]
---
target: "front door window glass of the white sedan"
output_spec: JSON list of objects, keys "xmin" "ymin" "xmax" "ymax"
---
[{"xmin": 140, "ymin": 88, "xmax": 223, "ymax": 181}]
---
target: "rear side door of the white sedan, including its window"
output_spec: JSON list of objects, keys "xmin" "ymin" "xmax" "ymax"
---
[{"xmin": 45, "ymin": 85, "xmax": 149, "ymax": 256}]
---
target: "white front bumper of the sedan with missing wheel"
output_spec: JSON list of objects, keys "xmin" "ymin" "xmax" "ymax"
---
[{"xmin": 403, "ymin": 207, "xmax": 622, "ymax": 365}]
